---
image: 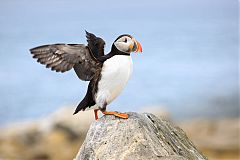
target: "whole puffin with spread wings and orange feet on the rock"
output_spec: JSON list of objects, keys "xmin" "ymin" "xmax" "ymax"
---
[{"xmin": 30, "ymin": 31, "xmax": 142, "ymax": 119}]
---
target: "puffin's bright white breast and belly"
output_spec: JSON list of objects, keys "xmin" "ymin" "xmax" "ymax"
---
[{"xmin": 95, "ymin": 55, "xmax": 132, "ymax": 107}]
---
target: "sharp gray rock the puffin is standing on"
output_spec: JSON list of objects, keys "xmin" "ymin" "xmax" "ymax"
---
[{"xmin": 75, "ymin": 113, "xmax": 207, "ymax": 160}]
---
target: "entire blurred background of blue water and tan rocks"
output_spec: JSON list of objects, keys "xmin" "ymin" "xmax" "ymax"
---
[{"xmin": 0, "ymin": 0, "xmax": 239, "ymax": 159}]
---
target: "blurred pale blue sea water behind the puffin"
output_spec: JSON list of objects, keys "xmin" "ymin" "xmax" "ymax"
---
[{"xmin": 0, "ymin": 0, "xmax": 239, "ymax": 125}]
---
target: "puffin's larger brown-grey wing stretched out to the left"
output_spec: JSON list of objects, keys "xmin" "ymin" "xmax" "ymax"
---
[{"xmin": 30, "ymin": 44, "xmax": 101, "ymax": 81}]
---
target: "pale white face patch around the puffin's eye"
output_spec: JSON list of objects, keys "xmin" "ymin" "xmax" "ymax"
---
[{"xmin": 114, "ymin": 36, "xmax": 134, "ymax": 53}]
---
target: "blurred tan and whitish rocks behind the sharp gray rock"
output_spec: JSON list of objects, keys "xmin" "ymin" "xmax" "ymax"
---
[{"xmin": 0, "ymin": 106, "xmax": 240, "ymax": 160}]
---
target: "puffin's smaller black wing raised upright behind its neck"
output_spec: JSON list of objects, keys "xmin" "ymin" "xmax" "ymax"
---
[{"xmin": 86, "ymin": 31, "xmax": 105, "ymax": 58}]
